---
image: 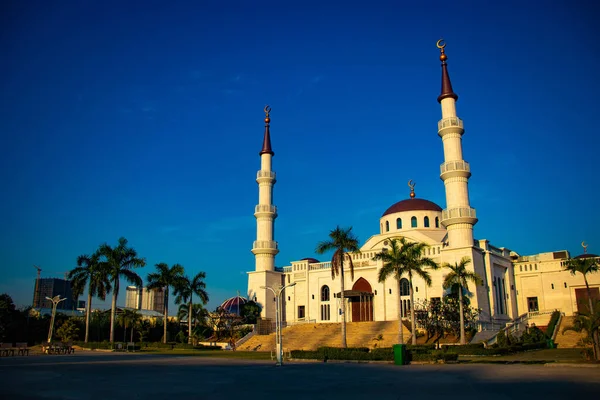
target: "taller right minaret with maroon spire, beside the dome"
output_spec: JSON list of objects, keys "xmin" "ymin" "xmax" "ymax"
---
[{"xmin": 437, "ymin": 40, "xmax": 477, "ymax": 248}]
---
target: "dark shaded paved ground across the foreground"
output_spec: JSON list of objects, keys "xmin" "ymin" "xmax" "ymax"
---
[{"xmin": 0, "ymin": 352, "xmax": 600, "ymax": 400}]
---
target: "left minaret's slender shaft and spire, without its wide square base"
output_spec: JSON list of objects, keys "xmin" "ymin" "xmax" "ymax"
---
[{"xmin": 252, "ymin": 106, "xmax": 279, "ymax": 271}]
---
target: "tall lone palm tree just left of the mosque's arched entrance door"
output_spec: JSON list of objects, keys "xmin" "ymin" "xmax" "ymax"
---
[{"xmin": 315, "ymin": 226, "xmax": 360, "ymax": 348}]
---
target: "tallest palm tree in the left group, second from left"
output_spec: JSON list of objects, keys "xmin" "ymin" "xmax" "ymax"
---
[{"xmin": 98, "ymin": 237, "xmax": 146, "ymax": 343}]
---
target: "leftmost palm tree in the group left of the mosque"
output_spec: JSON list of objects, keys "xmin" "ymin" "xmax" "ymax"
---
[{"xmin": 67, "ymin": 252, "xmax": 111, "ymax": 343}]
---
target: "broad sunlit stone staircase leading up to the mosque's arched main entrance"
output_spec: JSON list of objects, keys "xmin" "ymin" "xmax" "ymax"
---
[{"xmin": 237, "ymin": 321, "xmax": 410, "ymax": 351}]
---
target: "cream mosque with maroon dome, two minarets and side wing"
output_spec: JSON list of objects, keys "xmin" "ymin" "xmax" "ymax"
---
[{"xmin": 248, "ymin": 41, "xmax": 600, "ymax": 324}]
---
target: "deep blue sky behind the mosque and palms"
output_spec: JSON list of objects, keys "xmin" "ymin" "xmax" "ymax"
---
[{"xmin": 0, "ymin": 0, "xmax": 600, "ymax": 308}]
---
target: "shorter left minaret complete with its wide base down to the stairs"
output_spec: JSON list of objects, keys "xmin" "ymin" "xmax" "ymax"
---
[{"xmin": 248, "ymin": 106, "xmax": 283, "ymax": 321}]
